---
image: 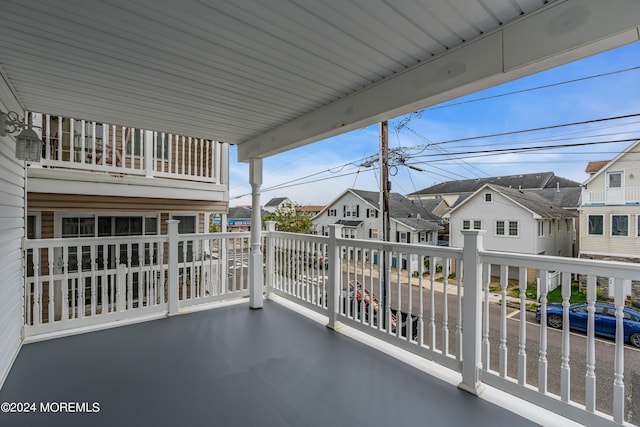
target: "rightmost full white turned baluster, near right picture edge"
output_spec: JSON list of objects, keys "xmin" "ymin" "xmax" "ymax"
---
[{"xmin": 613, "ymin": 278, "xmax": 626, "ymax": 424}]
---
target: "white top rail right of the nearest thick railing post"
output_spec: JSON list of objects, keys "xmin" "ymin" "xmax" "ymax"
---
[{"xmin": 480, "ymin": 250, "xmax": 640, "ymax": 280}]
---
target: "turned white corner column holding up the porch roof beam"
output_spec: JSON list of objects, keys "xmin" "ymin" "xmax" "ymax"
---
[{"xmin": 249, "ymin": 159, "xmax": 264, "ymax": 308}]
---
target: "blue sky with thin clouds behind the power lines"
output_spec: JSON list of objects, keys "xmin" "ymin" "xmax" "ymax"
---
[{"xmin": 229, "ymin": 43, "xmax": 640, "ymax": 206}]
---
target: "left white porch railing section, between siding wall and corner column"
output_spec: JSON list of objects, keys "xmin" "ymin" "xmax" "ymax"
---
[{"xmin": 24, "ymin": 221, "xmax": 249, "ymax": 337}]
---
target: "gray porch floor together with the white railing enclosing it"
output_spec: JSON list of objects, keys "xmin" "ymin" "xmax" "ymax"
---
[{"xmin": 2, "ymin": 226, "xmax": 640, "ymax": 426}]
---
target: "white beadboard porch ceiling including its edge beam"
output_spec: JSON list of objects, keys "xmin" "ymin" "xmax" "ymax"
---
[{"xmin": 0, "ymin": 0, "xmax": 640, "ymax": 160}]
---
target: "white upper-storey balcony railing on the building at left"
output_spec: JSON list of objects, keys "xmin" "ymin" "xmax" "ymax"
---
[{"xmin": 30, "ymin": 113, "xmax": 227, "ymax": 183}]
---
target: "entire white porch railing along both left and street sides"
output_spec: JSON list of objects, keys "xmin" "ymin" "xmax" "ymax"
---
[{"xmin": 24, "ymin": 226, "xmax": 640, "ymax": 426}]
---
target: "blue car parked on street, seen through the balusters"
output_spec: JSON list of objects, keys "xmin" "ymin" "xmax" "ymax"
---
[{"xmin": 536, "ymin": 303, "xmax": 640, "ymax": 347}]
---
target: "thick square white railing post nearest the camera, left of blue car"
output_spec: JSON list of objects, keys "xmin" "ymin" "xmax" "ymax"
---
[{"xmin": 458, "ymin": 230, "xmax": 485, "ymax": 395}]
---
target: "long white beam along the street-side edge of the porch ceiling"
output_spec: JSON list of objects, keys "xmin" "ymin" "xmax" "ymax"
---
[{"xmin": 238, "ymin": 0, "xmax": 640, "ymax": 162}]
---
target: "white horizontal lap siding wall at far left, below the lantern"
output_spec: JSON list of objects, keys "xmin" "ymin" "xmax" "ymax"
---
[{"xmin": 0, "ymin": 137, "xmax": 24, "ymax": 392}]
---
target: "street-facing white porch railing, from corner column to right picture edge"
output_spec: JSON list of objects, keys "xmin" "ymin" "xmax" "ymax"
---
[{"xmin": 266, "ymin": 229, "xmax": 640, "ymax": 426}]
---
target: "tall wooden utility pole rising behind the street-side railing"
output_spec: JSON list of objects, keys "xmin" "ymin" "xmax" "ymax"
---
[{"xmin": 378, "ymin": 120, "xmax": 391, "ymax": 328}]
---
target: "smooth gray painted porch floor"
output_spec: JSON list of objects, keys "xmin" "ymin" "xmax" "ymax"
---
[{"xmin": 0, "ymin": 301, "xmax": 535, "ymax": 427}]
